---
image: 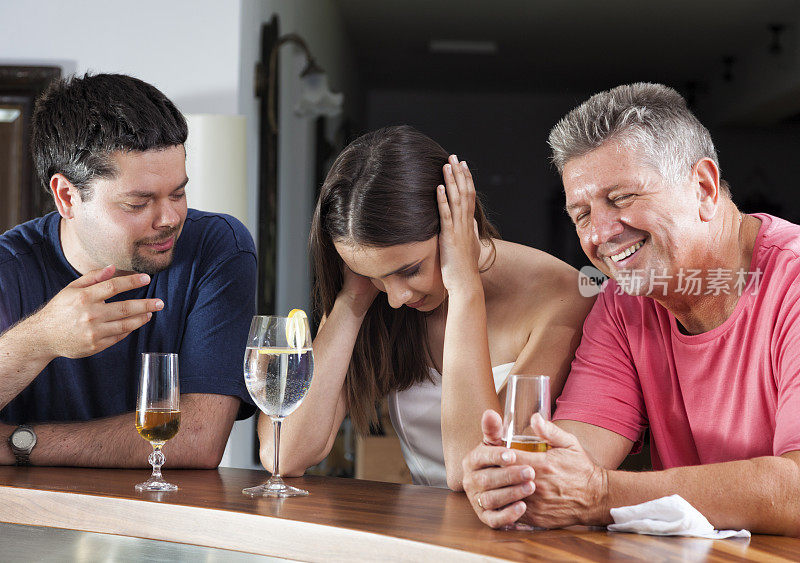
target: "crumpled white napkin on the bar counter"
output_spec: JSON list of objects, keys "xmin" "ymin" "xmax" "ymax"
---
[{"xmin": 608, "ymin": 495, "xmax": 750, "ymax": 540}]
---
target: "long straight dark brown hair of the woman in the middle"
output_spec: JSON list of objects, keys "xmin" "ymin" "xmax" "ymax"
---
[{"xmin": 309, "ymin": 126, "xmax": 498, "ymax": 433}]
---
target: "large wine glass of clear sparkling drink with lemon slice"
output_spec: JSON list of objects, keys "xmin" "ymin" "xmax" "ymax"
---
[{"xmin": 242, "ymin": 309, "xmax": 314, "ymax": 497}]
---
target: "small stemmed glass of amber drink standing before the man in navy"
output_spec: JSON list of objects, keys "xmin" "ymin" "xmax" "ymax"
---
[{"xmin": 136, "ymin": 353, "xmax": 181, "ymax": 492}]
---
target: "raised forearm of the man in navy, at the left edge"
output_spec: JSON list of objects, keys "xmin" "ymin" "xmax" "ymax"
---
[{"xmin": 0, "ymin": 317, "xmax": 54, "ymax": 410}]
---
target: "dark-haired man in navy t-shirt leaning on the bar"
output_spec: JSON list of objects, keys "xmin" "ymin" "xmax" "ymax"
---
[{"xmin": 0, "ymin": 74, "xmax": 256, "ymax": 468}]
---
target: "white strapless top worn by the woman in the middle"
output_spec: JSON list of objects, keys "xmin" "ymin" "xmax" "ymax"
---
[{"xmin": 387, "ymin": 362, "xmax": 514, "ymax": 487}]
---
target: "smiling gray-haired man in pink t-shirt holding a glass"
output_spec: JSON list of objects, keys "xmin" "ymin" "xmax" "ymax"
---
[{"xmin": 464, "ymin": 83, "xmax": 800, "ymax": 535}]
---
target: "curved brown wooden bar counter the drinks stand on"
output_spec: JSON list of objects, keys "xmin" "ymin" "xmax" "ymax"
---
[{"xmin": 0, "ymin": 465, "xmax": 800, "ymax": 563}]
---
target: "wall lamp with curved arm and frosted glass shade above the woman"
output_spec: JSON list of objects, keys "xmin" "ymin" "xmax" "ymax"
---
[{"xmin": 267, "ymin": 33, "xmax": 344, "ymax": 133}]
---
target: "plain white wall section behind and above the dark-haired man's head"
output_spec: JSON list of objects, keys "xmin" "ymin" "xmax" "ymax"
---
[{"xmin": 0, "ymin": 0, "xmax": 240, "ymax": 114}]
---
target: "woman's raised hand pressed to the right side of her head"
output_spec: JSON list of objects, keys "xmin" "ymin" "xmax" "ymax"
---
[{"xmin": 436, "ymin": 155, "xmax": 481, "ymax": 295}]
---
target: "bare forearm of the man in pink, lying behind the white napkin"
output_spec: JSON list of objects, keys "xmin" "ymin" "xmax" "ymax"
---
[{"xmin": 608, "ymin": 452, "xmax": 800, "ymax": 536}]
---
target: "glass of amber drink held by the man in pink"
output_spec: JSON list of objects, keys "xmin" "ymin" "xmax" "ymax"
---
[{"xmin": 503, "ymin": 375, "xmax": 550, "ymax": 452}]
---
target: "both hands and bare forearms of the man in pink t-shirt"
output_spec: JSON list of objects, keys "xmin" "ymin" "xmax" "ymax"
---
[{"xmin": 464, "ymin": 415, "xmax": 800, "ymax": 536}]
